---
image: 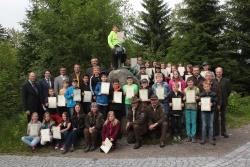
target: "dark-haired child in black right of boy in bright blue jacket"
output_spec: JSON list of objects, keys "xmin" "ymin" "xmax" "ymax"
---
[{"xmin": 80, "ymin": 74, "xmax": 91, "ymax": 114}]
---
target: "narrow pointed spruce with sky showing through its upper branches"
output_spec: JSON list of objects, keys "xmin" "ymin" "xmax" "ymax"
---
[{"xmin": 135, "ymin": 0, "xmax": 172, "ymax": 59}]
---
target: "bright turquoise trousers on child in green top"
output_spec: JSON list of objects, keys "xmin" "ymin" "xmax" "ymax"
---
[{"xmin": 185, "ymin": 109, "xmax": 197, "ymax": 138}]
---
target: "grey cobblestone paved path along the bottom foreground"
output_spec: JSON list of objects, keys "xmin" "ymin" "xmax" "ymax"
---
[{"xmin": 0, "ymin": 142, "xmax": 250, "ymax": 167}]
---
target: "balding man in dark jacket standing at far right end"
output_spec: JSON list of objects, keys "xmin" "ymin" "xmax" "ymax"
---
[{"xmin": 214, "ymin": 67, "xmax": 231, "ymax": 138}]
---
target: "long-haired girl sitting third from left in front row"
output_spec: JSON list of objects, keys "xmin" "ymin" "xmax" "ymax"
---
[{"xmin": 55, "ymin": 112, "xmax": 71, "ymax": 151}]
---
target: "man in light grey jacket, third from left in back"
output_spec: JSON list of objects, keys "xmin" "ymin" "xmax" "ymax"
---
[{"xmin": 54, "ymin": 67, "xmax": 69, "ymax": 95}]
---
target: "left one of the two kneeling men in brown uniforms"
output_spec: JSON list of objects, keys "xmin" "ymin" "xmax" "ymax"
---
[{"xmin": 126, "ymin": 97, "xmax": 148, "ymax": 149}]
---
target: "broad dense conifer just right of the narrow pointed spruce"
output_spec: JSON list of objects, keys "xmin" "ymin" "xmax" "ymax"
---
[{"xmin": 168, "ymin": 0, "xmax": 224, "ymax": 64}]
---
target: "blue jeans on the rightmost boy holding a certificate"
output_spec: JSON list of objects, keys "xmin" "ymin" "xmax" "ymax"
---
[{"xmin": 201, "ymin": 111, "xmax": 214, "ymax": 141}]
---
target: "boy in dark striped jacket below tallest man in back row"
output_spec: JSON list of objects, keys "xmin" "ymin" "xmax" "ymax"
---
[{"xmin": 89, "ymin": 66, "xmax": 101, "ymax": 96}]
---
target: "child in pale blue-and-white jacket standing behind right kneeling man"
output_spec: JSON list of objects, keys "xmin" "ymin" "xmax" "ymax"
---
[{"xmin": 152, "ymin": 73, "xmax": 170, "ymax": 114}]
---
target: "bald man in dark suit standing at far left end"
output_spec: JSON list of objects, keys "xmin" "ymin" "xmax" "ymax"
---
[{"xmin": 22, "ymin": 72, "xmax": 44, "ymax": 121}]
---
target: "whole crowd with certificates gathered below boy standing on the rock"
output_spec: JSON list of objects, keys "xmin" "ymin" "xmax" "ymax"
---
[{"xmin": 22, "ymin": 57, "xmax": 231, "ymax": 153}]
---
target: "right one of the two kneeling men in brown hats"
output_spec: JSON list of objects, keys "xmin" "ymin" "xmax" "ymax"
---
[{"xmin": 148, "ymin": 95, "xmax": 168, "ymax": 147}]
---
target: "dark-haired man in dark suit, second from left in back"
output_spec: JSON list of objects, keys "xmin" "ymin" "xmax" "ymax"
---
[{"xmin": 39, "ymin": 70, "xmax": 54, "ymax": 102}]
